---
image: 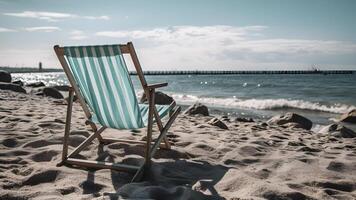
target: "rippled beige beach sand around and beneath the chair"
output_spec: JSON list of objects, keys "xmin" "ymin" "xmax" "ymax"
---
[{"xmin": 0, "ymin": 91, "xmax": 356, "ymax": 200}]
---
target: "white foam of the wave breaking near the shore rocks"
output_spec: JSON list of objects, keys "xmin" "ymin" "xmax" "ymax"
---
[{"xmin": 172, "ymin": 94, "xmax": 356, "ymax": 113}]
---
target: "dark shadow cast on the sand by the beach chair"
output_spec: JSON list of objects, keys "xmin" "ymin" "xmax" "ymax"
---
[{"xmin": 76, "ymin": 143, "xmax": 229, "ymax": 199}]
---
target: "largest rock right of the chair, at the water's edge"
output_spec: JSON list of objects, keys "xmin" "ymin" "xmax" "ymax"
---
[{"xmin": 267, "ymin": 113, "xmax": 313, "ymax": 130}]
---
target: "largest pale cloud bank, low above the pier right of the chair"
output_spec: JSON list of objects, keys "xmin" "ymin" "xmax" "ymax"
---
[{"xmin": 95, "ymin": 25, "xmax": 356, "ymax": 69}]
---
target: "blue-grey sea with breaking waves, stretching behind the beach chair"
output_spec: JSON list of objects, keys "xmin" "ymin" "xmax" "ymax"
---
[{"xmin": 12, "ymin": 72, "xmax": 356, "ymax": 130}]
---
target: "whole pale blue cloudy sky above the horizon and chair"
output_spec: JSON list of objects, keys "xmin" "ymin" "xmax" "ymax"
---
[{"xmin": 0, "ymin": 0, "xmax": 356, "ymax": 70}]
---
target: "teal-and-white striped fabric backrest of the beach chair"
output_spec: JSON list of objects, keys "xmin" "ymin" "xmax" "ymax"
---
[{"xmin": 63, "ymin": 45, "xmax": 144, "ymax": 129}]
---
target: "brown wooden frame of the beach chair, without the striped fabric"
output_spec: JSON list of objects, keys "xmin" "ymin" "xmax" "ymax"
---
[{"xmin": 54, "ymin": 42, "xmax": 181, "ymax": 181}]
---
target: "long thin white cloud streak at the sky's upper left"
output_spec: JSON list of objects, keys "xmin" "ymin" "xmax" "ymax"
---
[{"xmin": 3, "ymin": 11, "xmax": 110, "ymax": 22}]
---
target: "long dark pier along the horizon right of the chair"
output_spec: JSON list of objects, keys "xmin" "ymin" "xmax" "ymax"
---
[{"xmin": 130, "ymin": 70, "xmax": 356, "ymax": 75}]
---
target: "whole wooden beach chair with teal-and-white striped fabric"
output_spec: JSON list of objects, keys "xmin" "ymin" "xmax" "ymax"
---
[{"xmin": 54, "ymin": 42, "xmax": 181, "ymax": 181}]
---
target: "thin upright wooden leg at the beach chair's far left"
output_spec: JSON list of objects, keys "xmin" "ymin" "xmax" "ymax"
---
[{"xmin": 58, "ymin": 88, "xmax": 74, "ymax": 165}]
